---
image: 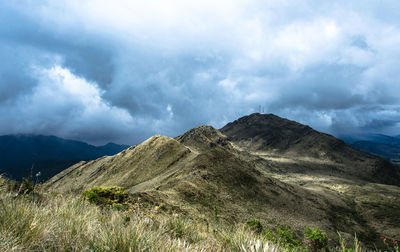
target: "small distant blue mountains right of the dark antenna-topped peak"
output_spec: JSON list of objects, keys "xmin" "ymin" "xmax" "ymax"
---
[{"xmin": 340, "ymin": 134, "xmax": 400, "ymax": 164}]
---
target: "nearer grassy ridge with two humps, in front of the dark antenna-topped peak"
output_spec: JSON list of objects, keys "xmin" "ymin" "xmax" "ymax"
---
[{"xmin": 47, "ymin": 126, "xmax": 346, "ymax": 238}]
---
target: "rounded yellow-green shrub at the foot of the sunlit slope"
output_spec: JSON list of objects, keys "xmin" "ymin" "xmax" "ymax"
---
[{"xmin": 82, "ymin": 186, "xmax": 128, "ymax": 209}]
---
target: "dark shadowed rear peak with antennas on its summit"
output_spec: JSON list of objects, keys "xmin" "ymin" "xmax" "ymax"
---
[{"xmin": 220, "ymin": 113, "xmax": 400, "ymax": 185}]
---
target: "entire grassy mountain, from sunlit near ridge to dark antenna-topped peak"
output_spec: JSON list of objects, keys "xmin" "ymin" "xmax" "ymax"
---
[{"xmin": 44, "ymin": 114, "xmax": 400, "ymax": 246}]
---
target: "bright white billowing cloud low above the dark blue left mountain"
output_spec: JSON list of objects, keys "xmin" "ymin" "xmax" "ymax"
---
[{"xmin": 0, "ymin": 66, "xmax": 138, "ymax": 142}]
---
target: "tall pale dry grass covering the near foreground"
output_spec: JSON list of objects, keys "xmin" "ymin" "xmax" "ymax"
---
[{"xmin": 0, "ymin": 180, "xmax": 398, "ymax": 251}]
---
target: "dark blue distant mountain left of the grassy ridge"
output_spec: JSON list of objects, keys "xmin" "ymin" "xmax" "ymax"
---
[{"xmin": 0, "ymin": 135, "xmax": 128, "ymax": 181}]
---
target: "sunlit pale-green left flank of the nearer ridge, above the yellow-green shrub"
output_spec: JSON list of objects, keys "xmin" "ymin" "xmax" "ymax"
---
[{"xmin": 46, "ymin": 135, "xmax": 193, "ymax": 192}]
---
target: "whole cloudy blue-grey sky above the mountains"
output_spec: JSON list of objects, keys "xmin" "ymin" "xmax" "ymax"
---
[{"xmin": 0, "ymin": 0, "xmax": 400, "ymax": 145}]
